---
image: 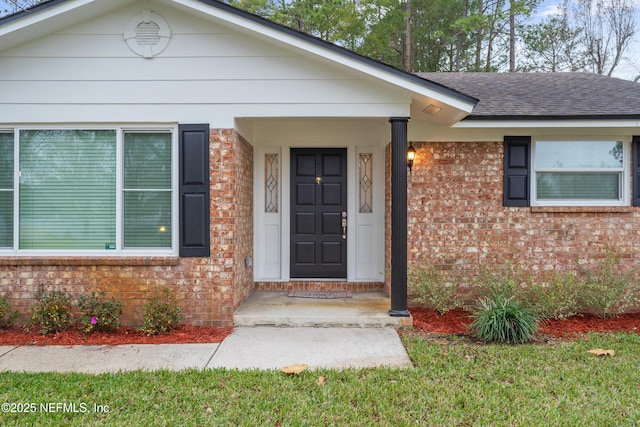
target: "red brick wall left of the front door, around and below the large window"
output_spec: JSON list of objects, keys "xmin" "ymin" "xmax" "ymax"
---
[{"xmin": 0, "ymin": 129, "xmax": 253, "ymax": 326}]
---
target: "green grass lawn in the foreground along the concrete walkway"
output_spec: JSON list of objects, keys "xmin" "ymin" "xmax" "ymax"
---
[{"xmin": 0, "ymin": 334, "xmax": 640, "ymax": 426}]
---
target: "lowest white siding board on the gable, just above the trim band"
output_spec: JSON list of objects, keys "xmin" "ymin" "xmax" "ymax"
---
[{"xmin": 0, "ymin": 80, "xmax": 400, "ymax": 104}]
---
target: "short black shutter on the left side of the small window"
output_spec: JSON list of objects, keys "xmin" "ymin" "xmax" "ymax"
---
[{"xmin": 503, "ymin": 136, "xmax": 531, "ymax": 206}]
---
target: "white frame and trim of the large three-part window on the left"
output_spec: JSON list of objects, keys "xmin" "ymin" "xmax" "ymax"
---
[{"xmin": 0, "ymin": 123, "xmax": 180, "ymax": 257}]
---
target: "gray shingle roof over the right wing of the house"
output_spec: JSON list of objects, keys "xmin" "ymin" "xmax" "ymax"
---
[{"xmin": 418, "ymin": 73, "xmax": 640, "ymax": 120}]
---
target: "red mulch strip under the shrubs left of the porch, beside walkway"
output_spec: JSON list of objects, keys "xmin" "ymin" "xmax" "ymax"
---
[{"xmin": 0, "ymin": 325, "xmax": 232, "ymax": 346}]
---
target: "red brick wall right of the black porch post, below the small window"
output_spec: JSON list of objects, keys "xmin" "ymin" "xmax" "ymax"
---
[{"xmin": 408, "ymin": 141, "xmax": 640, "ymax": 276}]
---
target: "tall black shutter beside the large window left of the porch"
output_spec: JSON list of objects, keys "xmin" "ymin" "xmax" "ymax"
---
[{"xmin": 179, "ymin": 124, "xmax": 210, "ymax": 257}]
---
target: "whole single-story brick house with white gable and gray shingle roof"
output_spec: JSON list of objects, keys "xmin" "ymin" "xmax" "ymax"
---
[{"xmin": 0, "ymin": 0, "xmax": 640, "ymax": 326}]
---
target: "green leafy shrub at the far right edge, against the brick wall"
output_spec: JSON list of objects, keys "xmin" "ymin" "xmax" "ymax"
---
[{"xmin": 578, "ymin": 248, "xmax": 640, "ymax": 318}]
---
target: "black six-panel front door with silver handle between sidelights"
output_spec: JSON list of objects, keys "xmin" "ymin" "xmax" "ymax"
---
[{"xmin": 290, "ymin": 148, "xmax": 347, "ymax": 279}]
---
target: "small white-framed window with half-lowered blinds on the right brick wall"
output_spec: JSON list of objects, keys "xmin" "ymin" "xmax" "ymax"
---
[{"xmin": 531, "ymin": 140, "xmax": 630, "ymax": 206}]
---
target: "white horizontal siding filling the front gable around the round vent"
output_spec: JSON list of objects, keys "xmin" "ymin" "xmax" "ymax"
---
[{"xmin": 0, "ymin": 3, "xmax": 411, "ymax": 127}]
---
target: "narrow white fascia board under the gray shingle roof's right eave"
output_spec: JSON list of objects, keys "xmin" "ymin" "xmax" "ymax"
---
[{"xmin": 452, "ymin": 119, "xmax": 640, "ymax": 129}]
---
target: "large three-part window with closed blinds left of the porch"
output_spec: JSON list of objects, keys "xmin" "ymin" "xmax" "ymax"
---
[{"xmin": 0, "ymin": 128, "xmax": 177, "ymax": 255}]
